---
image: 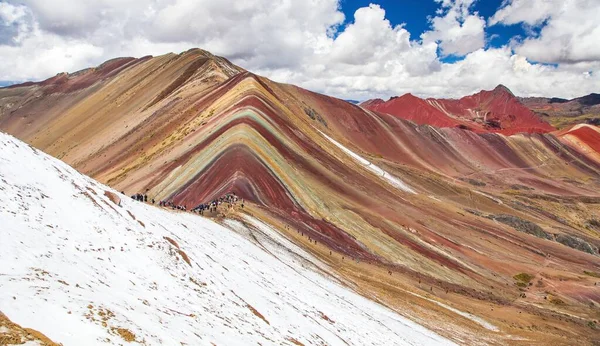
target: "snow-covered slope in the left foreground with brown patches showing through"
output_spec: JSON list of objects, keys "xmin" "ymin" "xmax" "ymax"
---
[{"xmin": 0, "ymin": 133, "xmax": 451, "ymax": 345}]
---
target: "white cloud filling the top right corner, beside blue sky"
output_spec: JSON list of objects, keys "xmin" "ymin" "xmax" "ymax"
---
[{"xmin": 489, "ymin": 0, "xmax": 600, "ymax": 64}]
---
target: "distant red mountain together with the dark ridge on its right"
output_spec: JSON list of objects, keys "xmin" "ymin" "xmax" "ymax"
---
[{"xmin": 361, "ymin": 85, "xmax": 600, "ymax": 135}]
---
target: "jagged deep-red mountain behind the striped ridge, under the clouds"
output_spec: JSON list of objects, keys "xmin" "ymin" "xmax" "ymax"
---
[{"xmin": 361, "ymin": 85, "xmax": 554, "ymax": 135}]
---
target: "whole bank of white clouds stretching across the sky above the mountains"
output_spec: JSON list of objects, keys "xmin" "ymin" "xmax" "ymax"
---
[{"xmin": 0, "ymin": 0, "xmax": 600, "ymax": 99}]
